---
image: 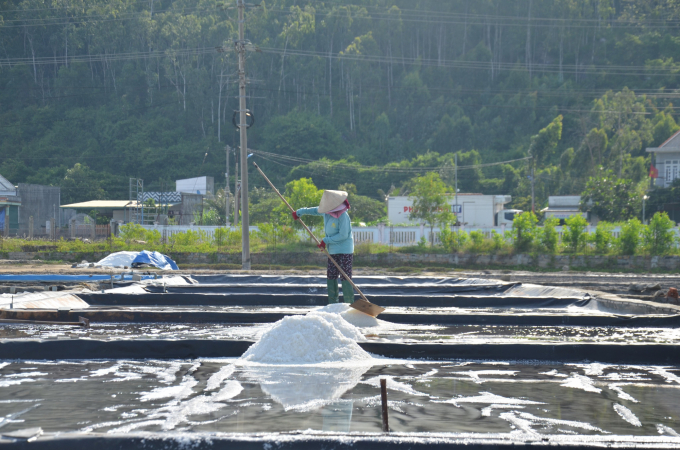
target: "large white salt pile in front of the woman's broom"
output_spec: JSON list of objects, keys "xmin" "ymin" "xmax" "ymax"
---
[{"xmin": 236, "ymin": 312, "xmax": 371, "ymax": 364}]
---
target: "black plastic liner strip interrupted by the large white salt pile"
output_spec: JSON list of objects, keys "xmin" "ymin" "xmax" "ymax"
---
[{"xmin": 0, "ymin": 339, "xmax": 680, "ymax": 365}]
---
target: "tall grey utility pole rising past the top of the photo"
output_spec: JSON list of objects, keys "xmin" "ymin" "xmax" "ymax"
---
[{"xmin": 236, "ymin": 0, "xmax": 250, "ymax": 270}]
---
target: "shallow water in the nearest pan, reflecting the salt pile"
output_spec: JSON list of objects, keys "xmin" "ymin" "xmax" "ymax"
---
[{"xmin": 0, "ymin": 359, "xmax": 680, "ymax": 438}]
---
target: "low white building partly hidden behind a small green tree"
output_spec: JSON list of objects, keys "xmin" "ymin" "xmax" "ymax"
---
[{"xmin": 387, "ymin": 194, "xmax": 516, "ymax": 227}]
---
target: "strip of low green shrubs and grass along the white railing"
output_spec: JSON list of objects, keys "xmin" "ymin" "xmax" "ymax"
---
[{"xmin": 0, "ymin": 212, "xmax": 680, "ymax": 256}]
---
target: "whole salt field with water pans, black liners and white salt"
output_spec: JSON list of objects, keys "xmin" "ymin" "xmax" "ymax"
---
[{"xmin": 0, "ymin": 276, "xmax": 680, "ymax": 449}]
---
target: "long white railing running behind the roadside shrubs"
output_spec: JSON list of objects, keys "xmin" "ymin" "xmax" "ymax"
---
[{"xmin": 137, "ymin": 224, "xmax": 680, "ymax": 247}]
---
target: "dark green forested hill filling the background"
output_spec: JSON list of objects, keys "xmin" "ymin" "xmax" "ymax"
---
[{"xmin": 0, "ymin": 0, "xmax": 680, "ymax": 211}]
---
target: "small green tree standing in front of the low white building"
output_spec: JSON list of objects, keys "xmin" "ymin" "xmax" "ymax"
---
[{"xmin": 409, "ymin": 172, "xmax": 453, "ymax": 246}]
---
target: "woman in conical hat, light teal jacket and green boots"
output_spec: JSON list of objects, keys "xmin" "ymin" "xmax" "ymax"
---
[{"xmin": 293, "ymin": 190, "xmax": 354, "ymax": 303}]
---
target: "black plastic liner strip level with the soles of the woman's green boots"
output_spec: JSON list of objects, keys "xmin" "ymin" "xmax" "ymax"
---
[{"xmin": 78, "ymin": 288, "xmax": 593, "ymax": 308}]
